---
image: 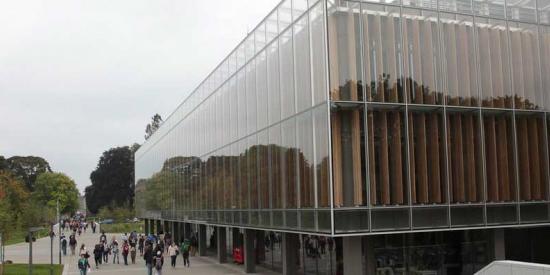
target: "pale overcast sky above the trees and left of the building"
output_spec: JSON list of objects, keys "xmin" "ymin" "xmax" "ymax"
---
[{"xmin": 0, "ymin": 0, "xmax": 279, "ymax": 191}]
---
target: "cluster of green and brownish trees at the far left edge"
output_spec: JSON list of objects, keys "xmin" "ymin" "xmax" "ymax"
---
[{"xmin": 0, "ymin": 156, "xmax": 80, "ymax": 242}]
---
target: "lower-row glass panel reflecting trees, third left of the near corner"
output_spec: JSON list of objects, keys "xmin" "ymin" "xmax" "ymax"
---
[{"xmin": 281, "ymin": 118, "xmax": 299, "ymax": 208}]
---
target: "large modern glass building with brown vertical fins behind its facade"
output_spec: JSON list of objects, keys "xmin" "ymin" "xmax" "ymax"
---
[{"xmin": 135, "ymin": 0, "xmax": 550, "ymax": 274}]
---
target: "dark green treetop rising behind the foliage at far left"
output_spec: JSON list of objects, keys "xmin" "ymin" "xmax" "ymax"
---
[{"xmin": 7, "ymin": 156, "xmax": 52, "ymax": 192}]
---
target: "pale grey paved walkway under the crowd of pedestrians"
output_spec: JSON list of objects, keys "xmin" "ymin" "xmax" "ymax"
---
[{"xmin": 5, "ymin": 227, "xmax": 278, "ymax": 275}]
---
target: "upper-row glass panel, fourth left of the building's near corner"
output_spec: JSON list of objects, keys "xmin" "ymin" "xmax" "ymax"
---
[{"xmin": 267, "ymin": 41, "xmax": 281, "ymax": 124}]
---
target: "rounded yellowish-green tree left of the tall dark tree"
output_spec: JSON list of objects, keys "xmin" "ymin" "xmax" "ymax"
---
[{"xmin": 32, "ymin": 173, "xmax": 80, "ymax": 214}]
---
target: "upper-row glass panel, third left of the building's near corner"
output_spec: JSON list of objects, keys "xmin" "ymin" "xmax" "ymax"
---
[{"xmin": 279, "ymin": 26, "xmax": 296, "ymax": 119}]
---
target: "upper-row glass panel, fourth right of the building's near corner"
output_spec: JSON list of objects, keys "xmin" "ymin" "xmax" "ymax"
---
[{"xmin": 440, "ymin": 13, "xmax": 479, "ymax": 106}]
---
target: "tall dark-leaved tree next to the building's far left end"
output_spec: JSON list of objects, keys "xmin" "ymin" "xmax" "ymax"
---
[{"xmin": 85, "ymin": 146, "xmax": 134, "ymax": 214}]
